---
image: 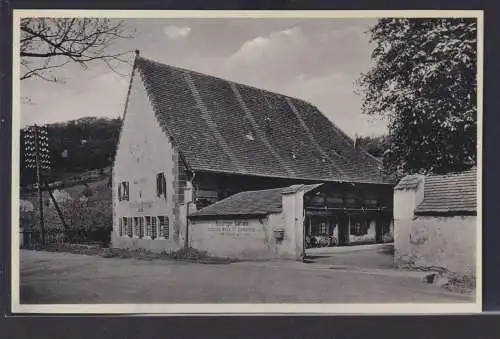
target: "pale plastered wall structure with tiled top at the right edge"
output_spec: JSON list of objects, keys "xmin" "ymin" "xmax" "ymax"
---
[{"xmin": 394, "ymin": 168, "xmax": 478, "ymax": 276}]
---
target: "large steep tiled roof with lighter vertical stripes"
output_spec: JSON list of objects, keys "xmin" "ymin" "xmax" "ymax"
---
[{"xmin": 135, "ymin": 57, "xmax": 387, "ymax": 183}]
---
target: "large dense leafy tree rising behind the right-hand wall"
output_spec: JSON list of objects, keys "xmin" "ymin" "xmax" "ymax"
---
[{"xmin": 357, "ymin": 18, "xmax": 477, "ymax": 173}]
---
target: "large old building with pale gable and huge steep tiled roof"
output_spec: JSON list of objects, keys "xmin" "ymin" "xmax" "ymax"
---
[{"xmin": 112, "ymin": 51, "xmax": 392, "ymax": 251}]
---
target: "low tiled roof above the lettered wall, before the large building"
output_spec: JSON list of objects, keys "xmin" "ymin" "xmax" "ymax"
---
[{"xmin": 190, "ymin": 187, "xmax": 288, "ymax": 217}]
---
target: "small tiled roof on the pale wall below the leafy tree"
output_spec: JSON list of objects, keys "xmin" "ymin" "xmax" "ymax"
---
[{"xmin": 415, "ymin": 168, "xmax": 477, "ymax": 215}]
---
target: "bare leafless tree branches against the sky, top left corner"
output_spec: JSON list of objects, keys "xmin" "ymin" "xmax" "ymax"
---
[{"xmin": 20, "ymin": 17, "xmax": 133, "ymax": 82}]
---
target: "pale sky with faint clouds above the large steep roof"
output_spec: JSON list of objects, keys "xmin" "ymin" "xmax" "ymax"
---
[{"xmin": 21, "ymin": 18, "xmax": 386, "ymax": 136}]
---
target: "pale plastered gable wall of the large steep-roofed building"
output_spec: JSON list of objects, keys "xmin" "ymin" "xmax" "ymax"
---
[{"xmin": 112, "ymin": 72, "xmax": 183, "ymax": 251}]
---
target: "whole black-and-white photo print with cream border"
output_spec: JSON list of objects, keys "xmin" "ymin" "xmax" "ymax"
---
[{"xmin": 12, "ymin": 10, "xmax": 483, "ymax": 314}]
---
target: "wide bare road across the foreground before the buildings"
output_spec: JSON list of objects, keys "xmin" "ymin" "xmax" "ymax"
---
[{"xmin": 20, "ymin": 250, "xmax": 473, "ymax": 304}]
